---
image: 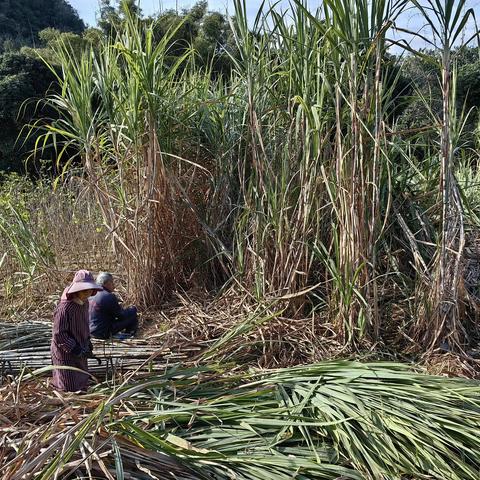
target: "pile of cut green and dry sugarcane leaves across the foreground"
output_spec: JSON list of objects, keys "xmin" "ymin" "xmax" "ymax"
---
[{"xmin": 0, "ymin": 361, "xmax": 480, "ymax": 480}]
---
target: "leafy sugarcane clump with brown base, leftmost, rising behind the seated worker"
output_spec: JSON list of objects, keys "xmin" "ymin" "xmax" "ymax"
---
[{"xmin": 31, "ymin": 14, "xmax": 212, "ymax": 305}]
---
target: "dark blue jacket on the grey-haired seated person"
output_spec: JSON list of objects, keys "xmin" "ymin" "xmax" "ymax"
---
[{"xmin": 89, "ymin": 290, "xmax": 123, "ymax": 338}]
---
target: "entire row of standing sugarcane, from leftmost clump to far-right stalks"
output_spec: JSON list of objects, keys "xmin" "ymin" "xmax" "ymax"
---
[{"xmin": 25, "ymin": 0, "xmax": 480, "ymax": 346}]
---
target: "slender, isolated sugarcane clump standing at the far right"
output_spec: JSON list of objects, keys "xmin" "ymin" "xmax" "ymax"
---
[{"xmin": 414, "ymin": 0, "xmax": 478, "ymax": 349}]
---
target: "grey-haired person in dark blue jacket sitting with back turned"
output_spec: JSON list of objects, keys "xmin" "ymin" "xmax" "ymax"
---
[{"xmin": 89, "ymin": 272, "xmax": 138, "ymax": 340}]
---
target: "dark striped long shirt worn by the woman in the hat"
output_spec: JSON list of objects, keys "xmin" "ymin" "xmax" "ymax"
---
[{"xmin": 51, "ymin": 299, "xmax": 90, "ymax": 392}]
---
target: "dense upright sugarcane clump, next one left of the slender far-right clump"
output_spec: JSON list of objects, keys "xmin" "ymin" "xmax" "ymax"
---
[{"xmin": 308, "ymin": 0, "xmax": 404, "ymax": 344}]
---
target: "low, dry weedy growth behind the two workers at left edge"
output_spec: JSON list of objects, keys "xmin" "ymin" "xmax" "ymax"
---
[{"xmin": 0, "ymin": 172, "xmax": 113, "ymax": 318}]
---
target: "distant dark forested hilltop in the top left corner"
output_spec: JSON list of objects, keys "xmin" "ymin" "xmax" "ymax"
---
[{"xmin": 0, "ymin": 0, "xmax": 85, "ymax": 46}]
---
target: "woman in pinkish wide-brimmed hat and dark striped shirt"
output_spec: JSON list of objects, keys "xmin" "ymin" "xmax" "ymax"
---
[{"xmin": 51, "ymin": 270, "xmax": 103, "ymax": 392}]
